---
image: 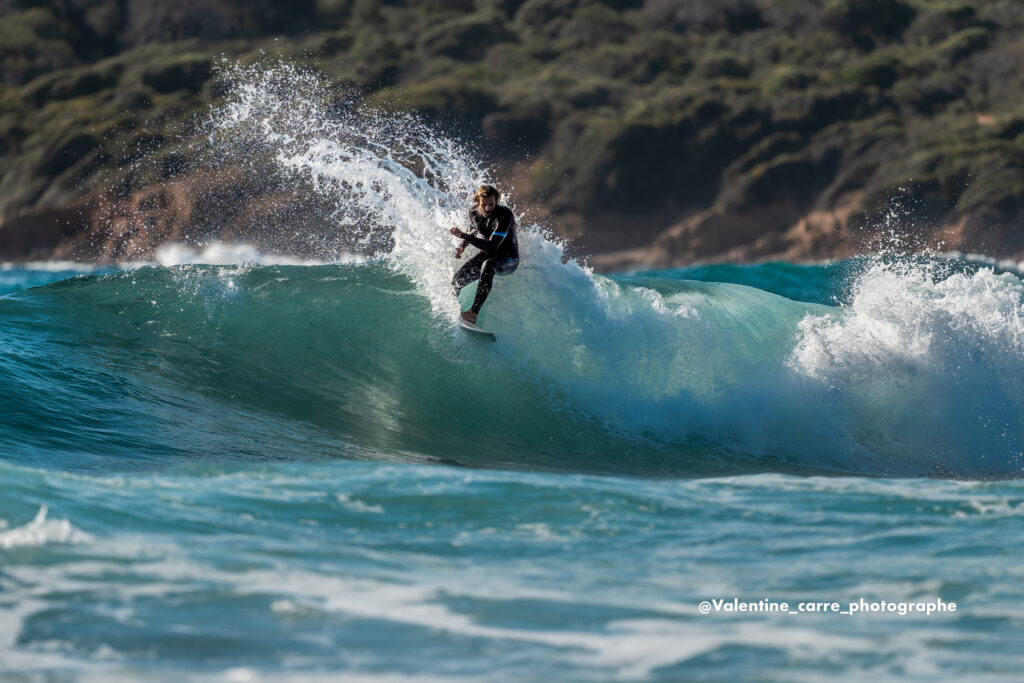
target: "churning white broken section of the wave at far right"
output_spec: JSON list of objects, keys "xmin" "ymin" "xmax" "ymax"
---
[{"xmin": 788, "ymin": 263, "xmax": 1024, "ymax": 477}]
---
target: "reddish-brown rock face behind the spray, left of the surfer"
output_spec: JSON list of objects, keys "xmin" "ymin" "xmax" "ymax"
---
[{"xmin": 0, "ymin": 170, "xmax": 372, "ymax": 263}]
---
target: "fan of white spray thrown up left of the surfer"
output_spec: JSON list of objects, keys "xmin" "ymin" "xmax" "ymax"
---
[{"xmin": 210, "ymin": 63, "xmax": 489, "ymax": 310}]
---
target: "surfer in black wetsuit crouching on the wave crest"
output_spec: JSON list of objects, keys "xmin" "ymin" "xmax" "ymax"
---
[{"xmin": 451, "ymin": 185, "xmax": 519, "ymax": 325}]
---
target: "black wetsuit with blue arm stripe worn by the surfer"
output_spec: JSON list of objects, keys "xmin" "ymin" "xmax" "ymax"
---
[{"xmin": 452, "ymin": 206, "xmax": 519, "ymax": 314}]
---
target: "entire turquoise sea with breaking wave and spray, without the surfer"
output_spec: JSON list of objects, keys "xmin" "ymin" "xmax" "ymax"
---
[{"xmin": 0, "ymin": 65, "xmax": 1024, "ymax": 681}]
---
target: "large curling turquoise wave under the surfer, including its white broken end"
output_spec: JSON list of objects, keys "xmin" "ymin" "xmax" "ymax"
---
[{"xmin": 6, "ymin": 252, "xmax": 1024, "ymax": 477}]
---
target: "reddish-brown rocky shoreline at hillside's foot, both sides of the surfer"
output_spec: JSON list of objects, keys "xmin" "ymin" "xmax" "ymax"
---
[{"xmin": 0, "ymin": 191, "xmax": 1024, "ymax": 272}]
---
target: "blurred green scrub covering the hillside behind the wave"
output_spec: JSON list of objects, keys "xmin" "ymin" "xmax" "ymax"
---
[{"xmin": 6, "ymin": 0, "xmax": 1024, "ymax": 262}]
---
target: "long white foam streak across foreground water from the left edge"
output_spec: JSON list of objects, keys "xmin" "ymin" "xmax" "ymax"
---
[{"xmin": 0, "ymin": 539, "xmax": 782, "ymax": 680}]
